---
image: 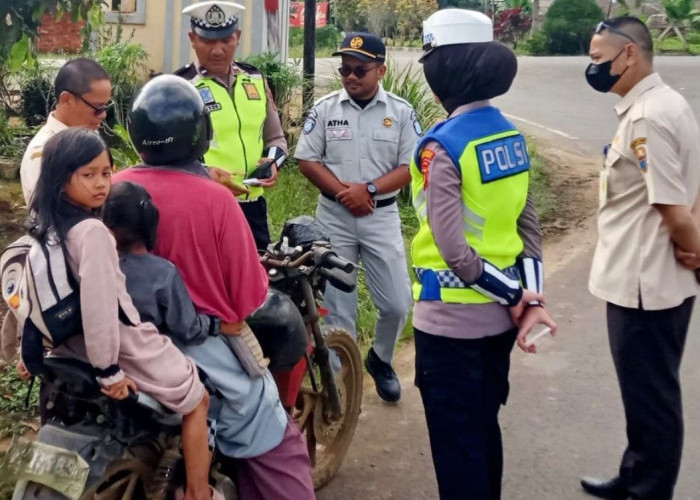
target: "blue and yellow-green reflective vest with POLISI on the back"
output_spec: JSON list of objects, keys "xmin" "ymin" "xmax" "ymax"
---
[{"xmin": 411, "ymin": 107, "xmax": 530, "ymax": 304}]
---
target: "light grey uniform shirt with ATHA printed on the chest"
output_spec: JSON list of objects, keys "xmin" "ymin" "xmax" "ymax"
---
[{"xmin": 294, "ymin": 85, "xmax": 422, "ymax": 199}]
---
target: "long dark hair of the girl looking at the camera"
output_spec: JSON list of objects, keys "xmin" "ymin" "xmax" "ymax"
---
[{"xmin": 29, "ymin": 127, "xmax": 113, "ymax": 242}]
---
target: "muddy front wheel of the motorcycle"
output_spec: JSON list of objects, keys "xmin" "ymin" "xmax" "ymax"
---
[{"xmin": 294, "ymin": 329, "xmax": 362, "ymax": 489}]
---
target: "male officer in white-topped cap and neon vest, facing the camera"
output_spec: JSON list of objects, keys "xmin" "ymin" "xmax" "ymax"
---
[{"xmin": 175, "ymin": 1, "xmax": 287, "ymax": 250}]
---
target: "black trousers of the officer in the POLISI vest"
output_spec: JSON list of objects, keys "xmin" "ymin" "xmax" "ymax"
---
[{"xmin": 414, "ymin": 329, "xmax": 517, "ymax": 500}]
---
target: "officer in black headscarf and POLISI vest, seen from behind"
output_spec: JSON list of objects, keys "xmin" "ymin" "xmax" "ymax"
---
[{"xmin": 410, "ymin": 9, "xmax": 556, "ymax": 500}]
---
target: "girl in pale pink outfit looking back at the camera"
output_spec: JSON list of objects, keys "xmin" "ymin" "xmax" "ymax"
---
[{"xmin": 30, "ymin": 128, "xmax": 211, "ymax": 500}]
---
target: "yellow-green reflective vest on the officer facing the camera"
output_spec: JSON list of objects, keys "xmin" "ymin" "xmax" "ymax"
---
[{"xmin": 192, "ymin": 69, "xmax": 267, "ymax": 200}]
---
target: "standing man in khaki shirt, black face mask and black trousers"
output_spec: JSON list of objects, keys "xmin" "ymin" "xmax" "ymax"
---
[{"xmin": 581, "ymin": 17, "xmax": 700, "ymax": 500}]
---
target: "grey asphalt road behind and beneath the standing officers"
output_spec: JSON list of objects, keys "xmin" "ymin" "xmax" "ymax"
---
[{"xmin": 318, "ymin": 53, "xmax": 700, "ymax": 500}]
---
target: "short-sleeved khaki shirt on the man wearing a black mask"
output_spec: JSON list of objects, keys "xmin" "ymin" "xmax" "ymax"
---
[{"xmin": 589, "ymin": 73, "xmax": 700, "ymax": 310}]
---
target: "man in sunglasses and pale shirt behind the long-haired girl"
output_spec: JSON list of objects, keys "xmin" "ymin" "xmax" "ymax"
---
[{"xmin": 19, "ymin": 57, "xmax": 112, "ymax": 205}]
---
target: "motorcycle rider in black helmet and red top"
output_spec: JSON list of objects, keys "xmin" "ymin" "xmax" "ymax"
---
[{"xmin": 113, "ymin": 75, "xmax": 315, "ymax": 500}]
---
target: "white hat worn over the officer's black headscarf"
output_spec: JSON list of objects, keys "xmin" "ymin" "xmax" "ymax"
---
[{"xmin": 420, "ymin": 9, "xmax": 493, "ymax": 61}]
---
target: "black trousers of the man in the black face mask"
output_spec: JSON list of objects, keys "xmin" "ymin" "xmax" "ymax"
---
[{"xmin": 607, "ymin": 297, "xmax": 695, "ymax": 500}]
